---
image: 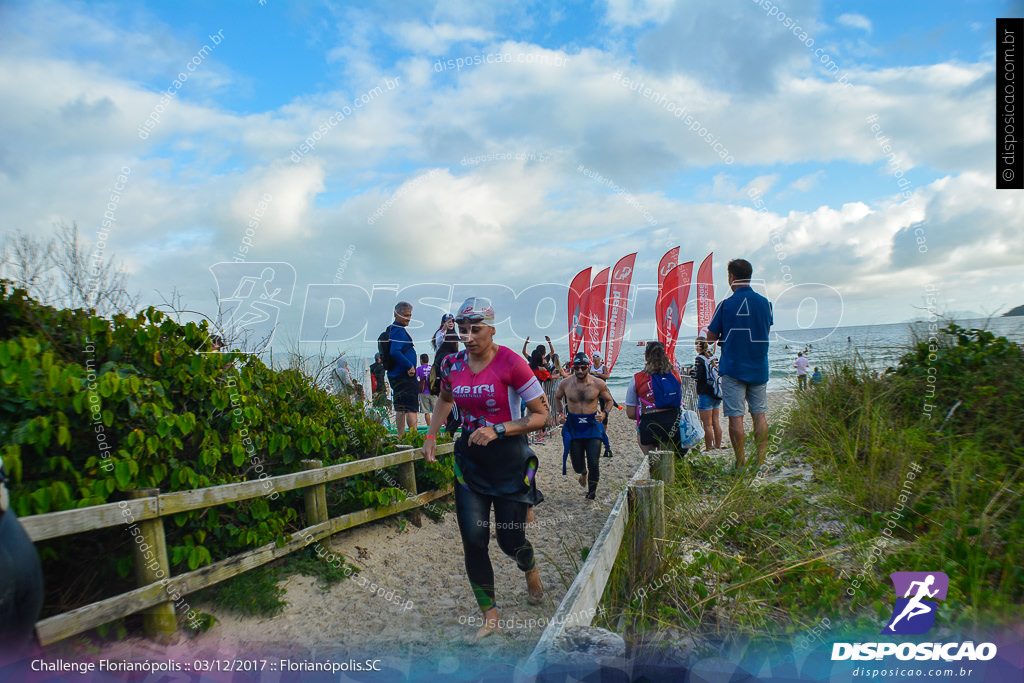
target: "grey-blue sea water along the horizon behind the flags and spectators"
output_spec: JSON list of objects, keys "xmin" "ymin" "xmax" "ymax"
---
[{"xmin": 608, "ymin": 316, "xmax": 1024, "ymax": 402}]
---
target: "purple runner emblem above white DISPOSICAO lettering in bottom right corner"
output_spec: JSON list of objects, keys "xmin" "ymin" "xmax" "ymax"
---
[{"xmin": 831, "ymin": 571, "xmax": 996, "ymax": 661}]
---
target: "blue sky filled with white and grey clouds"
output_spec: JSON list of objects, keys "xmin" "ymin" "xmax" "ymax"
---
[{"xmin": 0, "ymin": 0, "xmax": 1024, "ymax": 346}]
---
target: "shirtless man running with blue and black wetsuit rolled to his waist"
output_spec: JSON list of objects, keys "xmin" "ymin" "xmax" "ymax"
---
[{"xmin": 555, "ymin": 353, "xmax": 611, "ymax": 501}]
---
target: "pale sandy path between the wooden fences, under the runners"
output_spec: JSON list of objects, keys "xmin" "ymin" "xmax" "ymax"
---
[{"xmin": 92, "ymin": 392, "xmax": 787, "ymax": 673}]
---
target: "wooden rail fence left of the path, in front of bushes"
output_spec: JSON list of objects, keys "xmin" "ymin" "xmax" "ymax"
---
[{"xmin": 20, "ymin": 443, "xmax": 454, "ymax": 645}]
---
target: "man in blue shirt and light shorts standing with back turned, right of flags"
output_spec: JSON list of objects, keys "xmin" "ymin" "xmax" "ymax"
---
[{"xmin": 708, "ymin": 258, "xmax": 774, "ymax": 469}]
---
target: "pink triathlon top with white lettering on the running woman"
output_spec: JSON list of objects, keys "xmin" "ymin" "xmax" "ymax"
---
[{"xmin": 440, "ymin": 346, "xmax": 544, "ymax": 431}]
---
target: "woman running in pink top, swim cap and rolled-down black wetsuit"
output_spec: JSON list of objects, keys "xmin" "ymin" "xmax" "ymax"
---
[{"xmin": 423, "ymin": 297, "xmax": 548, "ymax": 638}]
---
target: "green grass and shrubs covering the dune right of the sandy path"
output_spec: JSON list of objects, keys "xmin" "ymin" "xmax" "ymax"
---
[{"xmin": 604, "ymin": 325, "xmax": 1024, "ymax": 649}]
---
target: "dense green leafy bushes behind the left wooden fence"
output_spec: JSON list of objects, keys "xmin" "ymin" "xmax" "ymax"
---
[{"xmin": 0, "ymin": 281, "xmax": 452, "ymax": 616}]
